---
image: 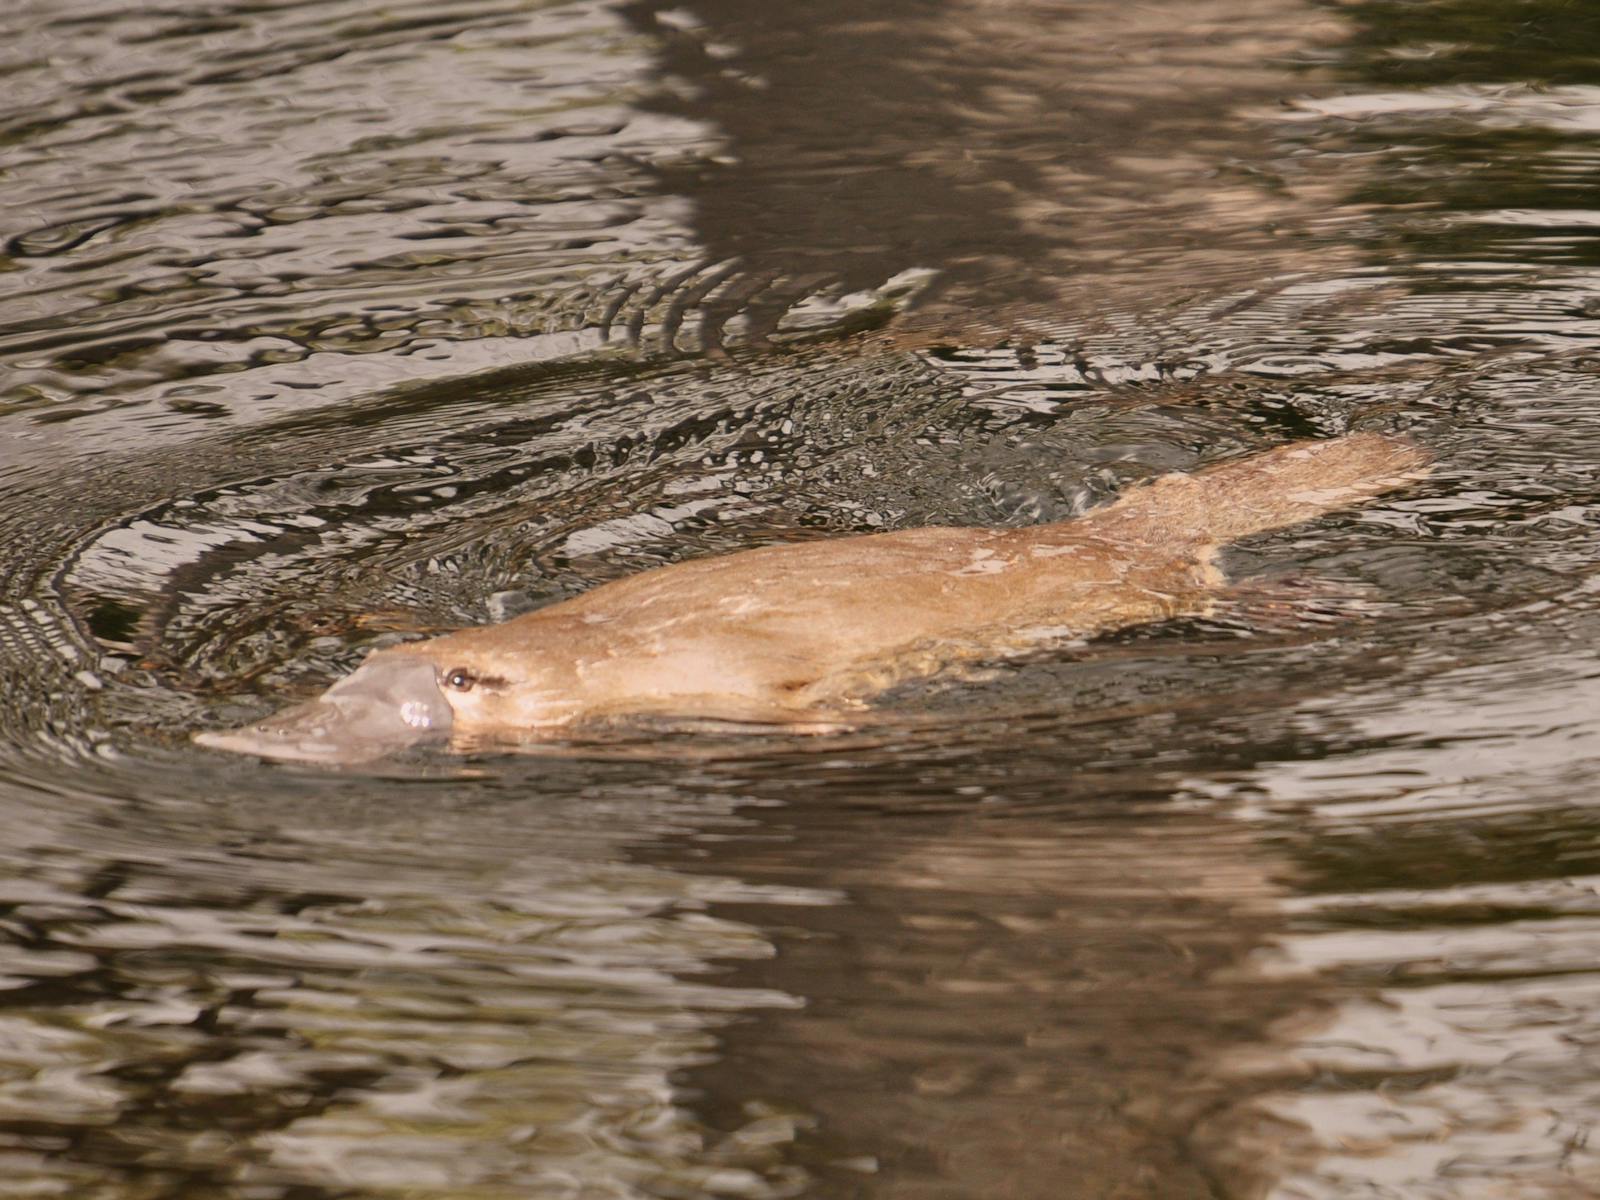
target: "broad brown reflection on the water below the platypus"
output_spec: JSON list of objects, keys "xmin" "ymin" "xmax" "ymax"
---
[{"xmin": 634, "ymin": 718, "xmax": 1315, "ymax": 1200}]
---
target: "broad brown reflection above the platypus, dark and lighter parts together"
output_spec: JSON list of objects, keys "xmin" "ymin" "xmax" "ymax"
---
[{"xmin": 621, "ymin": 0, "xmax": 1337, "ymax": 344}]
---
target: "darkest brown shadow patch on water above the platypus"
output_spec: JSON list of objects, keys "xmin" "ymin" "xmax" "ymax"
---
[{"xmin": 621, "ymin": 0, "xmax": 1070, "ymax": 328}]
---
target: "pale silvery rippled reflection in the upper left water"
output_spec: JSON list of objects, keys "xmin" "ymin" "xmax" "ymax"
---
[{"xmin": 0, "ymin": 0, "xmax": 702, "ymax": 427}]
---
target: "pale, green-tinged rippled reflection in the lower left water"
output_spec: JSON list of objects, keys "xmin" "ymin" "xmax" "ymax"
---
[{"xmin": 0, "ymin": 755, "xmax": 830, "ymax": 1195}]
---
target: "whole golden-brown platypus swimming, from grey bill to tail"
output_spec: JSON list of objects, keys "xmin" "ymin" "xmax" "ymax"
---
[{"xmin": 195, "ymin": 434, "xmax": 1429, "ymax": 763}]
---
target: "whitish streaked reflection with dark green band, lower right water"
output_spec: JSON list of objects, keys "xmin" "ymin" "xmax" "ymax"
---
[{"xmin": 1216, "ymin": 630, "xmax": 1600, "ymax": 1197}]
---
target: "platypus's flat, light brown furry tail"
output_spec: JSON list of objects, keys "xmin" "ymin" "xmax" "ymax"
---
[{"xmin": 1080, "ymin": 434, "xmax": 1432, "ymax": 546}]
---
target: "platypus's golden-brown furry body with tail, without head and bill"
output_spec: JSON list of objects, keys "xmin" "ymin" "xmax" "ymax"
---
[{"xmin": 518, "ymin": 434, "xmax": 1427, "ymax": 707}]
